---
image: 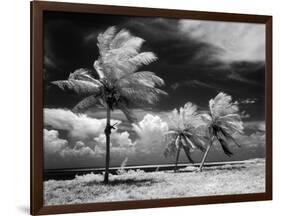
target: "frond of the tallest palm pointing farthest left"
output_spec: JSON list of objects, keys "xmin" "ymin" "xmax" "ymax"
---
[{"xmin": 52, "ymin": 79, "xmax": 100, "ymax": 95}]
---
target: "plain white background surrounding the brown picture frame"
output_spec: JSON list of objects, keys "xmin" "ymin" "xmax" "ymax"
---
[{"xmin": 0, "ymin": 0, "xmax": 281, "ymax": 216}]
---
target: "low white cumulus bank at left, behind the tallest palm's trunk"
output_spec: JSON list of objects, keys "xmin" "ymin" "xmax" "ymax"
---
[{"xmin": 44, "ymin": 109, "xmax": 133, "ymax": 163}]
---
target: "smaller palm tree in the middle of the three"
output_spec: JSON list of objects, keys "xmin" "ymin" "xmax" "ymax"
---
[{"xmin": 164, "ymin": 103, "xmax": 205, "ymax": 172}]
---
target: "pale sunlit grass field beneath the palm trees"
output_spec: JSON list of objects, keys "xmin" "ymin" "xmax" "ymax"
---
[{"xmin": 44, "ymin": 159, "xmax": 265, "ymax": 205}]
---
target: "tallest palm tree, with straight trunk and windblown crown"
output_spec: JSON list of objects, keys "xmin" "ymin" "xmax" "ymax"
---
[{"xmin": 53, "ymin": 26, "xmax": 166, "ymax": 184}]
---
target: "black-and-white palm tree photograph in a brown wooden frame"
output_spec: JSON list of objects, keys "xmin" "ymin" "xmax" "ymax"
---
[{"xmin": 31, "ymin": 1, "xmax": 272, "ymax": 215}]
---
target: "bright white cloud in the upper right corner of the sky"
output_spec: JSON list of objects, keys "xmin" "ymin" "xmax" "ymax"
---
[{"xmin": 179, "ymin": 20, "xmax": 265, "ymax": 62}]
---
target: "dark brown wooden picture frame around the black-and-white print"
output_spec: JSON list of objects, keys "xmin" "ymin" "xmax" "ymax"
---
[{"xmin": 30, "ymin": 1, "xmax": 272, "ymax": 215}]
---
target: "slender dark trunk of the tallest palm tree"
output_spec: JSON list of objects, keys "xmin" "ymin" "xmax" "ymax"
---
[{"xmin": 104, "ymin": 107, "xmax": 111, "ymax": 184}]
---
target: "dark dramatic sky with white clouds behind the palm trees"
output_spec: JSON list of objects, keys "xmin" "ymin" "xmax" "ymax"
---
[{"xmin": 44, "ymin": 12, "xmax": 265, "ymax": 169}]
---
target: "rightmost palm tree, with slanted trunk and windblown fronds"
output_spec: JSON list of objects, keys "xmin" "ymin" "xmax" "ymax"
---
[{"xmin": 199, "ymin": 92, "xmax": 243, "ymax": 171}]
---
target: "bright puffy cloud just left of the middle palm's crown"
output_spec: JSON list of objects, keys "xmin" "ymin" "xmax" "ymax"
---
[{"xmin": 133, "ymin": 114, "xmax": 168, "ymax": 153}]
